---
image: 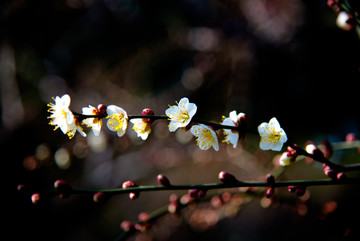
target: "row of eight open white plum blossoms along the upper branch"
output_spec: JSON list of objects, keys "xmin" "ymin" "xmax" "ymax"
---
[{"xmin": 48, "ymin": 94, "xmax": 287, "ymax": 151}]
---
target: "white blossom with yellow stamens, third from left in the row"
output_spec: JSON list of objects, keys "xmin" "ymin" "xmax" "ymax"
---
[{"xmin": 106, "ymin": 105, "xmax": 129, "ymax": 137}]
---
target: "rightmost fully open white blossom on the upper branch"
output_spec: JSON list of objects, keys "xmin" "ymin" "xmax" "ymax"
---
[{"xmin": 258, "ymin": 117, "xmax": 287, "ymax": 151}]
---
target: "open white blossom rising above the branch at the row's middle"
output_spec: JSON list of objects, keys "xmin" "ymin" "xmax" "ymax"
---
[{"xmin": 165, "ymin": 97, "xmax": 197, "ymax": 132}]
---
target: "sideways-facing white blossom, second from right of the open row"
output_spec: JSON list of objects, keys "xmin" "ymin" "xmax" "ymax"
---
[{"xmin": 221, "ymin": 110, "xmax": 246, "ymax": 148}]
